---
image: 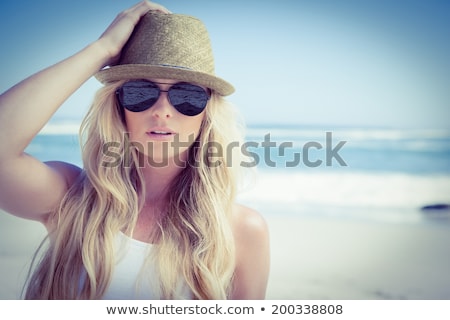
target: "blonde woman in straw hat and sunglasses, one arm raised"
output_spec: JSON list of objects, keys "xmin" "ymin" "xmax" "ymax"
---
[{"xmin": 0, "ymin": 1, "xmax": 269, "ymax": 299}]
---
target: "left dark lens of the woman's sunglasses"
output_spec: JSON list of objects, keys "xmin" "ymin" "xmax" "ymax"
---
[{"xmin": 117, "ymin": 80, "xmax": 159, "ymax": 112}]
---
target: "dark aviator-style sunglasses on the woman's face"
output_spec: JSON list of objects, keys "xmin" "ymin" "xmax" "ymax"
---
[{"xmin": 116, "ymin": 80, "xmax": 210, "ymax": 116}]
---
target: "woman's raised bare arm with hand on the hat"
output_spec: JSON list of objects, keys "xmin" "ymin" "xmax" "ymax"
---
[{"xmin": 0, "ymin": 1, "xmax": 167, "ymax": 221}]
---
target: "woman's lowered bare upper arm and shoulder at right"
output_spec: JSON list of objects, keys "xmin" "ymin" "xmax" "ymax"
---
[{"xmin": 230, "ymin": 206, "xmax": 270, "ymax": 300}]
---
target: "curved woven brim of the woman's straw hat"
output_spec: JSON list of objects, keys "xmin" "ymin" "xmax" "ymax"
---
[{"xmin": 95, "ymin": 64, "xmax": 234, "ymax": 96}]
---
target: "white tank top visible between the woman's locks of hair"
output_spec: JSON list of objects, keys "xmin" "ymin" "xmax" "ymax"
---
[{"xmin": 103, "ymin": 233, "xmax": 192, "ymax": 300}]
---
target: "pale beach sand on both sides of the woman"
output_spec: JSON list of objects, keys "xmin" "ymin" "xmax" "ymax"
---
[{"xmin": 0, "ymin": 208, "xmax": 450, "ymax": 300}]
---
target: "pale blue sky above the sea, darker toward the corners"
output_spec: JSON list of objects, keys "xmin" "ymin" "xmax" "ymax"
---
[{"xmin": 0, "ymin": 0, "xmax": 450, "ymax": 129}]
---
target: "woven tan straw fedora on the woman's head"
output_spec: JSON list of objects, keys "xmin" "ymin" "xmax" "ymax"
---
[{"xmin": 95, "ymin": 11, "xmax": 234, "ymax": 96}]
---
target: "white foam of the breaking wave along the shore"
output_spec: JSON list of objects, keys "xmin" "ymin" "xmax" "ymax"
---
[{"xmin": 240, "ymin": 170, "xmax": 450, "ymax": 221}]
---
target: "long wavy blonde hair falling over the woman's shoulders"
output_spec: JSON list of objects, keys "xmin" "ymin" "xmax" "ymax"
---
[{"xmin": 25, "ymin": 82, "xmax": 246, "ymax": 299}]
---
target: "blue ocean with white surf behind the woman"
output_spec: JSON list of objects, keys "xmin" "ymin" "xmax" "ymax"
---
[{"xmin": 23, "ymin": 123, "xmax": 450, "ymax": 223}]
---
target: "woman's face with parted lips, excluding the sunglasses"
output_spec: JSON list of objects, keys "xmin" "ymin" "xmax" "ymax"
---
[{"xmin": 124, "ymin": 79, "xmax": 205, "ymax": 166}]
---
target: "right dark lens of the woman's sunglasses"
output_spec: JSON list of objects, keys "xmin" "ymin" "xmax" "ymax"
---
[{"xmin": 169, "ymin": 83, "xmax": 209, "ymax": 116}]
